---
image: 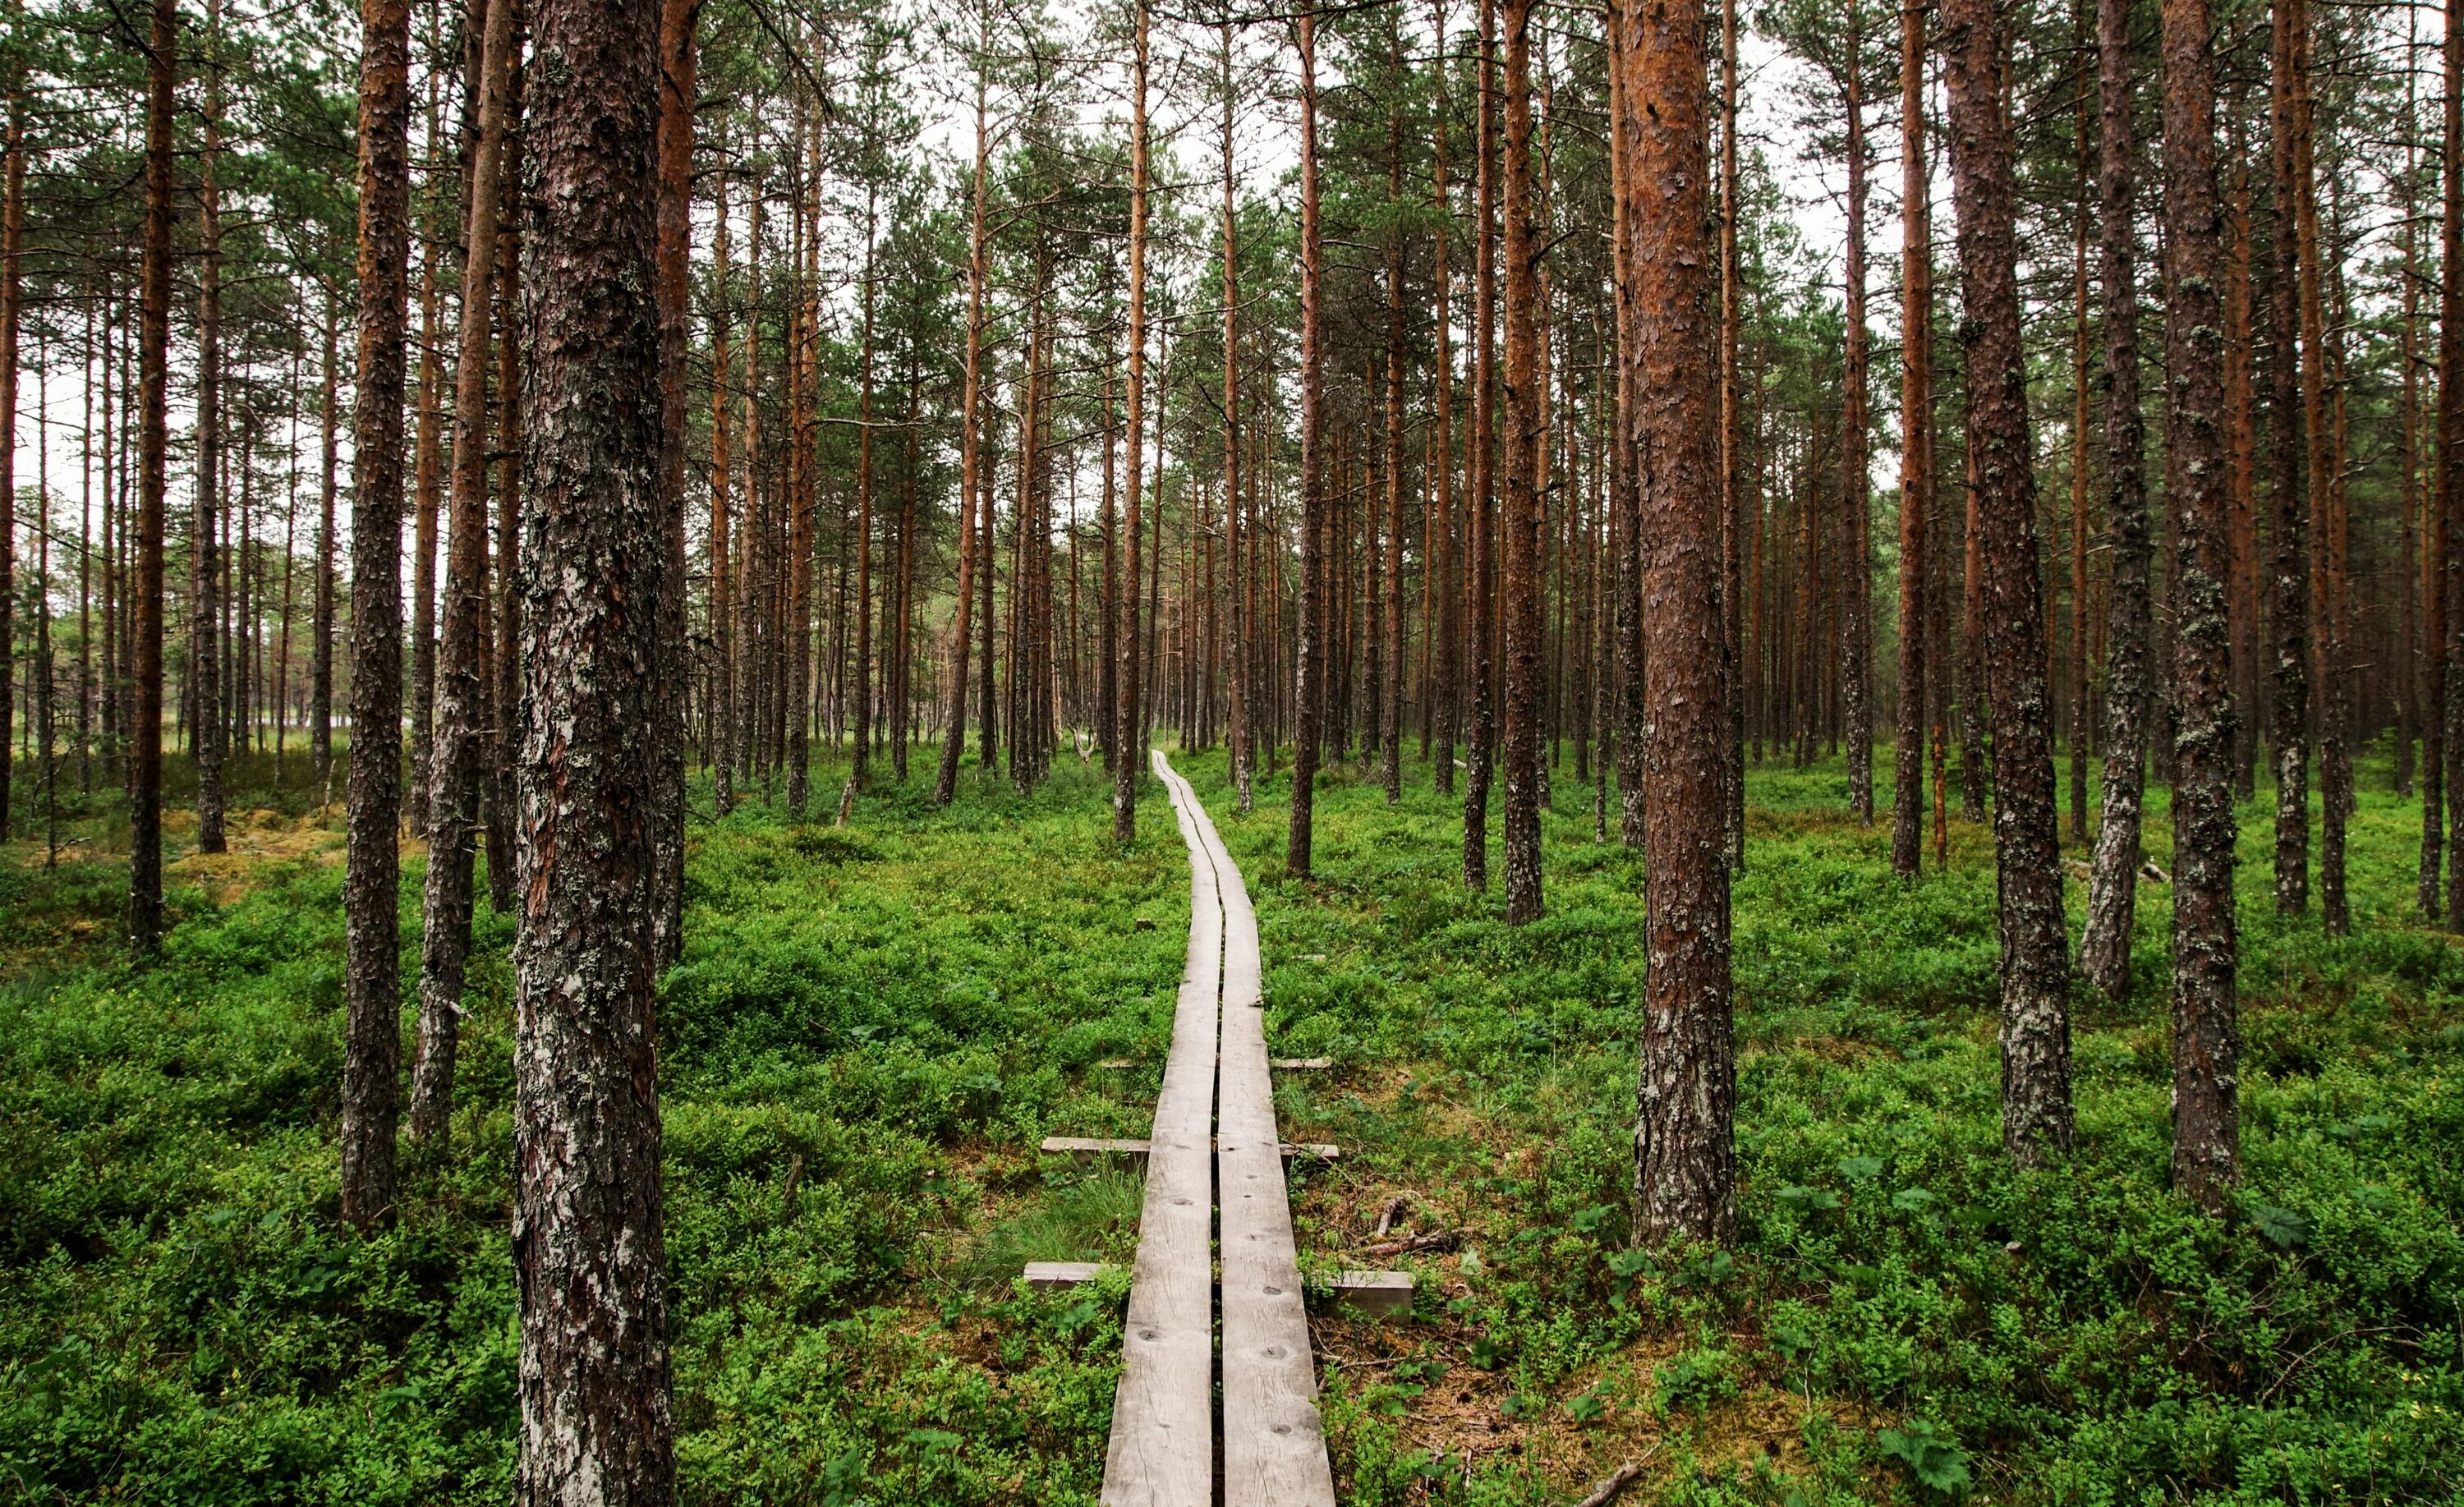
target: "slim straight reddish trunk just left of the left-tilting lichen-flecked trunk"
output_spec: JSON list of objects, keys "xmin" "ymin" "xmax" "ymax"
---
[{"xmin": 1890, "ymin": 0, "xmax": 1934, "ymax": 876}]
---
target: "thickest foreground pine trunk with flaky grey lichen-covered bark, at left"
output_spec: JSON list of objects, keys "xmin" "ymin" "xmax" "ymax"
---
[{"xmin": 513, "ymin": 0, "xmax": 680, "ymax": 1507}]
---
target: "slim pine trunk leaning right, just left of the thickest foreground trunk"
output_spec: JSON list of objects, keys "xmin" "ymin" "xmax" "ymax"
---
[{"xmin": 411, "ymin": 0, "xmax": 513, "ymax": 1152}]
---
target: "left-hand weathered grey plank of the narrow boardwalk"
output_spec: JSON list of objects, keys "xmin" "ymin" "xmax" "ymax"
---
[{"xmin": 1104, "ymin": 754, "xmax": 1222, "ymax": 1507}]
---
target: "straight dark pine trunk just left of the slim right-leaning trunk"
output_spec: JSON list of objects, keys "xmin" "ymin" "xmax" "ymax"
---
[{"xmin": 340, "ymin": 0, "xmax": 411, "ymax": 1229}]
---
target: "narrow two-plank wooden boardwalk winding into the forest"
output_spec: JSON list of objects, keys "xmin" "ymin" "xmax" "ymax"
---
[{"xmin": 1104, "ymin": 751, "xmax": 1335, "ymax": 1507}]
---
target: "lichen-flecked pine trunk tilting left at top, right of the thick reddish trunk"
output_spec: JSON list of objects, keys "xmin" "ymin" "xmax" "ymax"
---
[{"xmin": 1944, "ymin": 0, "xmax": 2072, "ymax": 1167}]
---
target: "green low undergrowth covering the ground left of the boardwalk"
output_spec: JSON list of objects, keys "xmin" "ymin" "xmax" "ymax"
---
[{"xmin": 0, "ymin": 760, "xmax": 1188, "ymax": 1507}]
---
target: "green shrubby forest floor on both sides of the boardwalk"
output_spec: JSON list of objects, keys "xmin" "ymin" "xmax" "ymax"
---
[{"xmin": 0, "ymin": 733, "xmax": 2464, "ymax": 1507}]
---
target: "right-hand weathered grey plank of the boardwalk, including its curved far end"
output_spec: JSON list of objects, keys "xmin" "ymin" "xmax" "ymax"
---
[{"xmin": 1156, "ymin": 751, "xmax": 1335, "ymax": 1507}]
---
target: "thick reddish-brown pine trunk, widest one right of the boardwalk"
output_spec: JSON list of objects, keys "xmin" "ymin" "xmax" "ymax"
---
[{"xmin": 1616, "ymin": 0, "xmax": 1737, "ymax": 1246}]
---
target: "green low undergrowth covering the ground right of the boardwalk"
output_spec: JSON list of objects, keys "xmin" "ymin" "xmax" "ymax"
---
[{"xmin": 1193, "ymin": 743, "xmax": 2464, "ymax": 1505}]
